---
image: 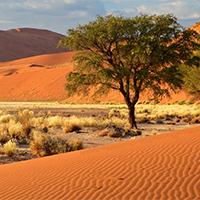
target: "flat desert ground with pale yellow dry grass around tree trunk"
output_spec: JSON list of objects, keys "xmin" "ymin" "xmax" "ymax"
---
[{"xmin": 0, "ymin": 102, "xmax": 200, "ymax": 164}]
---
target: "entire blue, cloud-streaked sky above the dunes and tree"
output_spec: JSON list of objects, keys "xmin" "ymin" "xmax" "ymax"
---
[{"xmin": 0, "ymin": 0, "xmax": 200, "ymax": 35}]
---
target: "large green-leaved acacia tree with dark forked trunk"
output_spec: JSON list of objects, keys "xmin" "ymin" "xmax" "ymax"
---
[{"xmin": 59, "ymin": 14, "xmax": 199, "ymax": 128}]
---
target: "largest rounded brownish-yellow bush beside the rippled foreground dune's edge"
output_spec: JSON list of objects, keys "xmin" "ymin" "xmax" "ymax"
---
[{"xmin": 30, "ymin": 133, "xmax": 70, "ymax": 156}]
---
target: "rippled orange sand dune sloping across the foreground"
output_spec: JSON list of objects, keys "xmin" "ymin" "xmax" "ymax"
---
[{"xmin": 0, "ymin": 127, "xmax": 200, "ymax": 200}]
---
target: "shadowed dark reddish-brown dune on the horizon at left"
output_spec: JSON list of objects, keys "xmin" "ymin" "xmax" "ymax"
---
[{"xmin": 0, "ymin": 28, "xmax": 68, "ymax": 62}]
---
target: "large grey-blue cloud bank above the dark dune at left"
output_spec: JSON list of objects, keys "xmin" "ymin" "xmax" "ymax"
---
[{"xmin": 0, "ymin": 0, "xmax": 106, "ymax": 34}]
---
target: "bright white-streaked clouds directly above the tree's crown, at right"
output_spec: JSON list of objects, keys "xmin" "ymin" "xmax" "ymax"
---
[{"xmin": 107, "ymin": 0, "xmax": 200, "ymax": 26}]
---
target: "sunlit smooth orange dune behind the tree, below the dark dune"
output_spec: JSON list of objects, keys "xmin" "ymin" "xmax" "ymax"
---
[{"xmin": 0, "ymin": 52, "xmax": 192, "ymax": 103}]
